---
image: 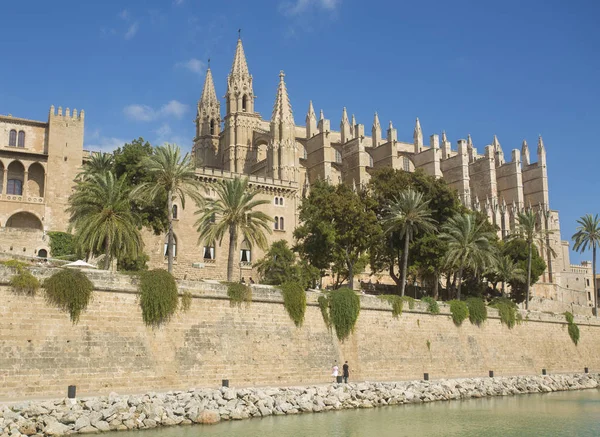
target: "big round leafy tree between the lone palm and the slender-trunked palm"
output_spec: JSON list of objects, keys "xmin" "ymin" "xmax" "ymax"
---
[{"xmin": 294, "ymin": 181, "xmax": 380, "ymax": 288}]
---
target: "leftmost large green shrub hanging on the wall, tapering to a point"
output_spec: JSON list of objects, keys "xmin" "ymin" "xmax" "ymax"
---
[{"xmin": 44, "ymin": 269, "xmax": 94, "ymax": 324}]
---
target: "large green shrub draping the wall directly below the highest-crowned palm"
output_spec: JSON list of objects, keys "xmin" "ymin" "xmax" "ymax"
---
[{"xmin": 138, "ymin": 270, "xmax": 179, "ymax": 326}]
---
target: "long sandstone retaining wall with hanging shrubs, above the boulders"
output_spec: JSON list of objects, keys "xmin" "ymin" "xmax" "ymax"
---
[{"xmin": 0, "ymin": 269, "xmax": 600, "ymax": 399}]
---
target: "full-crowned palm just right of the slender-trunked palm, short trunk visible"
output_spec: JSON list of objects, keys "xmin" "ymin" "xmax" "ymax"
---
[{"xmin": 440, "ymin": 213, "xmax": 495, "ymax": 300}]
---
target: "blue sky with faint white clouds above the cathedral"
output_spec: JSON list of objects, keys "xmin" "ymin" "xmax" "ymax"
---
[{"xmin": 0, "ymin": 0, "xmax": 600, "ymax": 262}]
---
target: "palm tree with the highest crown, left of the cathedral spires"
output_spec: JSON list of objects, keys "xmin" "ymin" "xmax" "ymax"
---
[{"xmin": 131, "ymin": 144, "xmax": 200, "ymax": 273}]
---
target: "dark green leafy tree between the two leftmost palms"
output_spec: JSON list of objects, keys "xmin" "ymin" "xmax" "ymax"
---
[{"xmin": 113, "ymin": 137, "xmax": 169, "ymax": 235}]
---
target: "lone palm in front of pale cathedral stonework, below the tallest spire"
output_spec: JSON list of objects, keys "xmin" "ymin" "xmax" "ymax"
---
[{"xmin": 196, "ymin": 177, "xmax": 272, "ymax": 282}]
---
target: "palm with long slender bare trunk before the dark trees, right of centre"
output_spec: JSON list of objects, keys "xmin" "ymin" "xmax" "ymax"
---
[{"xmin": 384, "ymin": 188, "xmax": 437, "ymax": 296}]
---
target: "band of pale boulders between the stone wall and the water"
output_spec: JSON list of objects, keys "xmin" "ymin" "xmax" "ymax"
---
[{"xmin": 0, "ymin": 374, "xmax": 600, "ymax": 437}]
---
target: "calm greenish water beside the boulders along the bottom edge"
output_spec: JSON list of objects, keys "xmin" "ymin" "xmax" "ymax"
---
[{"xmin": 102, "ymin": 390, "xmax": 600, "ymax": 437}]
